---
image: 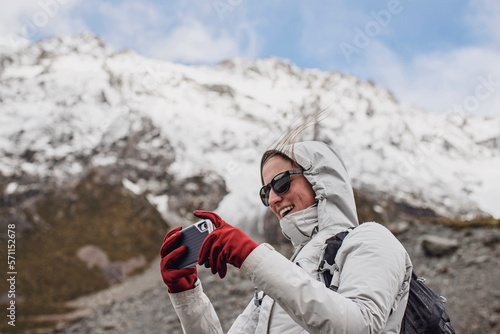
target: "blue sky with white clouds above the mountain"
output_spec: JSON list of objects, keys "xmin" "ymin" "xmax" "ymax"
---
[{"xmin": 0, "ymin": 0, "xmax": 500, "ymax": 116}]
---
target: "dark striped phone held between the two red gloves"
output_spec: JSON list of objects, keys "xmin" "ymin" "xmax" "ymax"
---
[{"xmin": 177, "ymin": 219, "xmax": 215, "ymax": 269}]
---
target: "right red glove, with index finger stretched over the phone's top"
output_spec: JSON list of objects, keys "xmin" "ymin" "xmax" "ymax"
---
[{"xmin": 194, "ymin": 210, "xmax": 258, "ymax": 278}]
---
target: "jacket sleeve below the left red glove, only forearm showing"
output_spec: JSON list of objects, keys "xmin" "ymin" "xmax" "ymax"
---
[{"xmin": 169, "ymin": 280, "xmax": 222, "ymax": 334}]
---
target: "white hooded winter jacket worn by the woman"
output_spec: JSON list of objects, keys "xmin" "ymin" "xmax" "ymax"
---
[{"xmin": 170, "ymin": 142, "xmax": 412, "ymax": 334}]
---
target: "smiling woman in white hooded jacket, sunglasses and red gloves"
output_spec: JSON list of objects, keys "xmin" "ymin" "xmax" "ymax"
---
[{"xmin": 161, "ymin": 142, "xmax": 412, "ymax": 334}]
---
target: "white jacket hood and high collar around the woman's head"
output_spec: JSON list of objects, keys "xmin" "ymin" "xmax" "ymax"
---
[{"xmin": 274, "ymin": 141, "xmax": 358, "ymax": 245}]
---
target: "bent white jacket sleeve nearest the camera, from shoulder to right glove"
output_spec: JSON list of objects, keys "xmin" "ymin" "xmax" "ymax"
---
[{"xmin": 241, "ymin": 224, "xmax": 411, "ymax": 333}]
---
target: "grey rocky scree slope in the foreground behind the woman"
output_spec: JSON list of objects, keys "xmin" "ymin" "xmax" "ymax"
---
[{"xmin": 55, "ymin": 222, "xmax": 500, "ymax": 334}]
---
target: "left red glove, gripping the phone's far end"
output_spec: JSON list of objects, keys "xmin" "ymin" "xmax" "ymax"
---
[{"xmin": 160, "ymin": 226, "xmax": 198, "ymax": 293}]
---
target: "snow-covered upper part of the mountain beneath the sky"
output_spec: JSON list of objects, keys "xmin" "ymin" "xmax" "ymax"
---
[{"xmin": 0, "ymin": 34, "xmax": 500, "ymax": 224}]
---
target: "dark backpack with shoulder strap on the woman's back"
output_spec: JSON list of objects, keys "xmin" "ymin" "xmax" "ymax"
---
[{"xmin": 318, "ymin": 231, "xmax": 455, "ymax": 334}]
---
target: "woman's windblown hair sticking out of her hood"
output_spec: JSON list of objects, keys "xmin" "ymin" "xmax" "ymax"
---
[{"xmin": 260, "ymin": 108, "xmax": 328, "ymax": 184}]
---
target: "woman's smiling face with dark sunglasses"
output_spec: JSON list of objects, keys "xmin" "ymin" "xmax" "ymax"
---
[{"xmin": 262, "ymin": 155, "xmax": 316, "ymax": 219}]
